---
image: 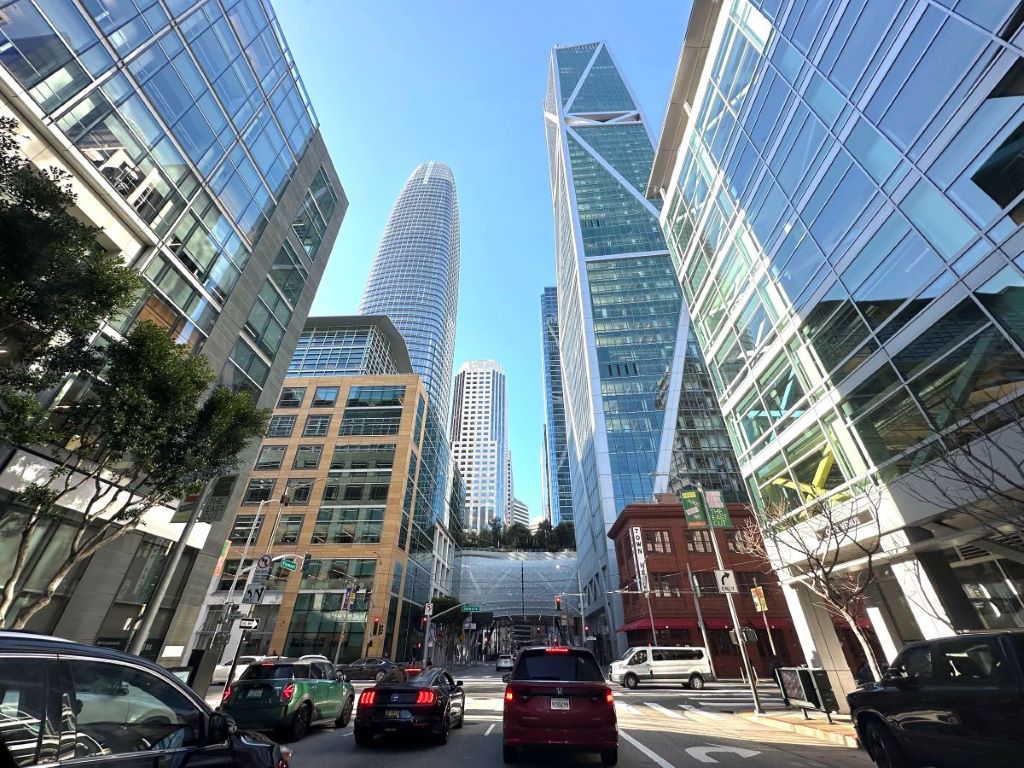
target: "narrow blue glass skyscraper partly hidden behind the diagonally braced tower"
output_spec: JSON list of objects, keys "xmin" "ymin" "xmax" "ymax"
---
[{"xmin": 541, "ymin": 288, "xmax": 572, "ymax": 525}]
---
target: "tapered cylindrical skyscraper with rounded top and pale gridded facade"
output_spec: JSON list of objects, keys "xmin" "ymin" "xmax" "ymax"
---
[{"xmin": 359, "ymin": 163, "xmax": 459, "ymax": 426}]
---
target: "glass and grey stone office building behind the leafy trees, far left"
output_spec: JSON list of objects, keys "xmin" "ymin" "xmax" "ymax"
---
[{"xmin": 0, "ymin": 0, "xmax": 347, "ymax": 656}]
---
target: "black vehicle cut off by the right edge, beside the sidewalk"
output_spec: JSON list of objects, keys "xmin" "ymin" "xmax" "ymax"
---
[{"xmin": 847, "ymin": 630, "xmax": 1024, "ymax": 768}]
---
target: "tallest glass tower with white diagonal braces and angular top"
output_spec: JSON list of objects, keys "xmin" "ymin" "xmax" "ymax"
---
[{"xmin": 544, "ymin": 43, "xmax": 741, "ymax": 654}]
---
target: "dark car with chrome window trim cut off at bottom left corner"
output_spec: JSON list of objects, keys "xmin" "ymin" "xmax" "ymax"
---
[{"xmin": 0, "ymin": 631, "xmax": 292, "ymax": 768}]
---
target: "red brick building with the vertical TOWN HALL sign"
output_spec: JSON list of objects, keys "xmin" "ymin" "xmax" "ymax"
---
[{"xmin": 608, "ymin": 502, "xmax": 804, "ymax": 678}]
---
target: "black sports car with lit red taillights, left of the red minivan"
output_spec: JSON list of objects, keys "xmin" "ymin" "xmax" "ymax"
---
[{"xmin": 355, "ymin": 667, "xmax": 466, "ymax": 746}]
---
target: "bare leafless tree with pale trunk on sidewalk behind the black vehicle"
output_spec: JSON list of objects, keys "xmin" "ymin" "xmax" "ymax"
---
[{"xmin": 736, "ymin": 496, "xmax": 882, "ymax": 680}]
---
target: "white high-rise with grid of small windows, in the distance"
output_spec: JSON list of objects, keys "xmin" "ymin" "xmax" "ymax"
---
[{"xmin": 452, "ymin": 360, "xmax": 511, "ymax": 530}]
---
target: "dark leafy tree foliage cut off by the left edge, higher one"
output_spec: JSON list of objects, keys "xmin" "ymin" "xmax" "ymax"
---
[{"xmin": 0, "ymin": 118, "xmax": 141, "ymax": 445}]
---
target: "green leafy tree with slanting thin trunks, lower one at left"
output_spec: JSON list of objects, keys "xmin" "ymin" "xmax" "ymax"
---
[{"xmin": 0, "ymin": 323, "xmax": 269, "ymax": 629}]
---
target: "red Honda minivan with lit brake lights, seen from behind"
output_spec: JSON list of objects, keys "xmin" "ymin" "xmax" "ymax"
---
[{"xmin": 502, "ymin": 646, "xmax": 618, "ymax": 765}]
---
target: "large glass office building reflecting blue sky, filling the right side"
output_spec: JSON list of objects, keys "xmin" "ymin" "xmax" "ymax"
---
[{"xmin": 648, "ymin": 0, "xmax": 1024, "ymax": 686}]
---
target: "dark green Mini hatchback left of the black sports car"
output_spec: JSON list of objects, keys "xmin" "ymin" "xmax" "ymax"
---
[{"xmin": 220, "ymin": 657, "xmax": 355, "ymax": 740}]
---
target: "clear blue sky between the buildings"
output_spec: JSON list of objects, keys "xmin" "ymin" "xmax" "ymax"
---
[{"xmin": 274, "ymin": 0, "xmax": 690, "ymax": 517}]
